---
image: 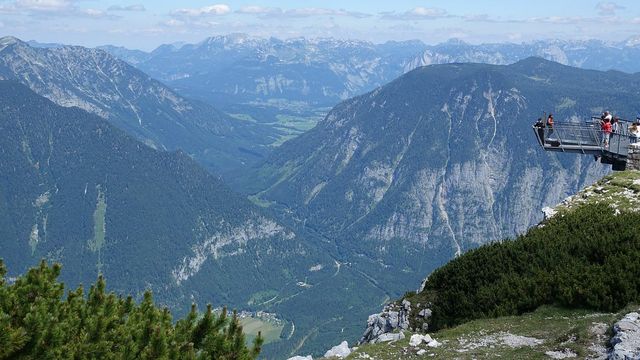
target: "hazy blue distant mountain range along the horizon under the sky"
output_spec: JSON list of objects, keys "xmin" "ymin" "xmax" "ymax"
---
[{"xmin": 95, "ymin": 34, "xmax": 640, "ymax": 114}]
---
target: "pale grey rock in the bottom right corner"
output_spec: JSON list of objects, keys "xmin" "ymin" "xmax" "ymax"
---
[{"xmin": 609, "ymin": 312, "xmax": 640, "ymax": 360}]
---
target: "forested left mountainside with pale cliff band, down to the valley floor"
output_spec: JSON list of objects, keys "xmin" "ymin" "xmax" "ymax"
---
[{"xmin": 0, "ymin": 81, "xmax": 389, "ymax": 359}]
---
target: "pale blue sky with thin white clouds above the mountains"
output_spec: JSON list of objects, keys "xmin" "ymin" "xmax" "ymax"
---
[{"xmin": 0, "ymin": 0, "xmax": 640, "ymax": 51}]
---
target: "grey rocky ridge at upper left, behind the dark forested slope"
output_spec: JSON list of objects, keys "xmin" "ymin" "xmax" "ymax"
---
[{"xmin": 0, "ymin": 37, "xmax": 280, "ymax": 173}]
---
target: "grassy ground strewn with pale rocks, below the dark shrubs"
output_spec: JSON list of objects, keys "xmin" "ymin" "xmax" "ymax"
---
[{"xmin": 347, "ymin": 306, "xmax": 637, "ymax": 360}]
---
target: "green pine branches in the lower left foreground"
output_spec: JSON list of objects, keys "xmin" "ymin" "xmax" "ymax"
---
[{"xmin": 0, "ymin": 260, "xmax": 262, "ymax": 360}]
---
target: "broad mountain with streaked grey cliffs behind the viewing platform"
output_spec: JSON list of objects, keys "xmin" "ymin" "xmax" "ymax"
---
[{"xmin": 250, "ymin": 59, "xmax": 638, "ymax": 291}]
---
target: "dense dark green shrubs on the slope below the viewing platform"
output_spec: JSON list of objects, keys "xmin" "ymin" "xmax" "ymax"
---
[{"xmin": 408, "ymin": 203, "xmax": 640, "ymax": 330}]
